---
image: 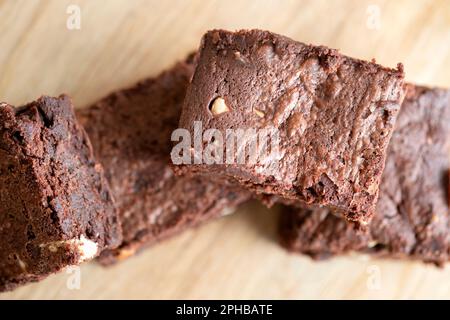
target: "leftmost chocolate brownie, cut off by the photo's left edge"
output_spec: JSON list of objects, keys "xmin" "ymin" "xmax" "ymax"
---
[{"xmin": 0, "ymin": 95, "xmax": 121, "ymax": 291}]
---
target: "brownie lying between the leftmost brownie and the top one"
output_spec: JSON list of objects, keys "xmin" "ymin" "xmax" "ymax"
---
[{"xmin": 78, "ymin": 56, "xmax": 248, "ymax": 264}]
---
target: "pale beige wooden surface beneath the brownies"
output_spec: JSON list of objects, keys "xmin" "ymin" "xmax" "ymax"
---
[{"xmin": 0, "ymin": 0, "xmax": 450, "ymax": 299}]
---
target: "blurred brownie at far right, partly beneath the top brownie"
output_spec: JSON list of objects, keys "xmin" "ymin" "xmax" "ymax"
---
[{"xmin": 280, "ymin": 85, "xmax": 450, "ymax": 264}]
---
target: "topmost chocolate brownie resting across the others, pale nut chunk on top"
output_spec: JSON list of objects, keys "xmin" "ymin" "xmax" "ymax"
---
[{"xmin": 175, "ymin": 30, "xmax": 404, "ymax": 222}]
